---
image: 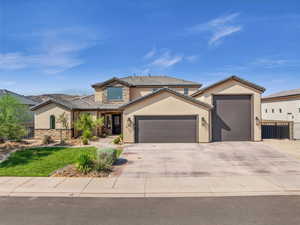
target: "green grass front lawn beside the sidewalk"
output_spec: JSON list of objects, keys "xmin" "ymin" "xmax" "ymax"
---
[{"xmin": 0, "ymin": 147, "xmax": 96, "ymax": 177}]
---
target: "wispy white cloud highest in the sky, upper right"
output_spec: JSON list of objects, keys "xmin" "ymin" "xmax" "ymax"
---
[{"xmin": 188, "ymin": 13, "xmax": 243, "ymax": 45}]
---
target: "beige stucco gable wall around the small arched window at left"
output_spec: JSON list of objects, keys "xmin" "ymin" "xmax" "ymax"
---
[{"xmin": 34, "ymin": 103, "xmax": 72, "ymax": 129}]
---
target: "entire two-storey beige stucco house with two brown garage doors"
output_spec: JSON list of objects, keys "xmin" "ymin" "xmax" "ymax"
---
[{"xmin": 32, "ymin": 76, "xmax": 265, "ymax": 143}]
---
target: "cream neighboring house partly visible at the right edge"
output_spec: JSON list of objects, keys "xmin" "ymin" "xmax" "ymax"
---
[{"xmin": 262, "ymin": 89, "xmax": 300, "ymax": 139}]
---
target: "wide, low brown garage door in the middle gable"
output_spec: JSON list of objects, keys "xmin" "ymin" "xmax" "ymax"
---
[{"xmin": 135, "ymin": 116, "xmax": 197, "ymax": 143}]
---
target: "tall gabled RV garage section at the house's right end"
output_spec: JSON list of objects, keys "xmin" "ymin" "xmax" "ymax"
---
[{"xmin": 192, "ymin": 76, "xmax": 265, "ymax": 141}]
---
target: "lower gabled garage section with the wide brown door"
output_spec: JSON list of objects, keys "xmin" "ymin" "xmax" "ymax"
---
[{"xmin": 122, "ymin": 88, "xmax": 212, "ymax": 143}]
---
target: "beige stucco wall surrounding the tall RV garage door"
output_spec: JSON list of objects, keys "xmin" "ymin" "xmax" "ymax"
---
[{"xmin": 195, "ymin": 80, "xmax": 261, "ymax": 141}]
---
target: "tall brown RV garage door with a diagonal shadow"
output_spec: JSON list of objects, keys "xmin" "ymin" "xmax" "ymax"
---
[{"xmin": 212, "ymin": 95, "xmax": 251, "ymax": 141}]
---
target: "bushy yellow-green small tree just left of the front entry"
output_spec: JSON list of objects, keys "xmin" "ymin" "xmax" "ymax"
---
[{"xmin": 75, "ymin": 113, "xmax": 104, "ymax": 144}]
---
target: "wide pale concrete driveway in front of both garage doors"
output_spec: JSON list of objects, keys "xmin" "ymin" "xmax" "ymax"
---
[{"xmin": 118, "ymin": 142, "xmax": 300, "ymax": 178}]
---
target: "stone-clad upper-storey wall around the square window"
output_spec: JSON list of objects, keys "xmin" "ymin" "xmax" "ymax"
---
[{"xmin": 95, "ymin": 82, "xmax": 130, "ymax": 104}]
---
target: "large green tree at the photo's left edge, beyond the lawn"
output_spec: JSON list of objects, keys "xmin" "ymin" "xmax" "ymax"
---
[{"xmin": 0, "ymin": 95, "xmax": 30, "ymax": 141}]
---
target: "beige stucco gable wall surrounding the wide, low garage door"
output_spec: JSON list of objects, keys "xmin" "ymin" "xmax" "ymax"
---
[{"xmin": 123, "ymin": 92, "xmax": 210, "ymax": 143}]
